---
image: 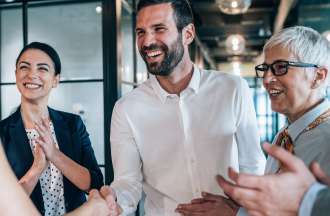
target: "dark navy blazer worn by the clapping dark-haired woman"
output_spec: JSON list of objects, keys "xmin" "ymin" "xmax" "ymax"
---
[{"xmin": 0, "ymin": 107, "xmax": 103, "ymax": 214}]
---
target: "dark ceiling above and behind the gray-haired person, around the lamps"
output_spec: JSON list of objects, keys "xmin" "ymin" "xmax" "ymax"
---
[{"xmin": 191, "ymin": 0, "xmax": 330, "ymax": 64}]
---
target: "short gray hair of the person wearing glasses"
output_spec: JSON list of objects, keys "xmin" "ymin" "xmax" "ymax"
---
[{"xmin": 263, "ymin": 26, "xmax": 330, "ymax": 71}]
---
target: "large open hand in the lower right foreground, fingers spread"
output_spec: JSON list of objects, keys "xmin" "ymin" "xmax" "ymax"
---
[{"xmin": 218, "ymin": 144, "xmax": 315, "ymax": 215}]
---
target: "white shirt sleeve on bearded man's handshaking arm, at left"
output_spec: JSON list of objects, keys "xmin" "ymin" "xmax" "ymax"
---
[{"xmin": 110, "ymin": 101, "xmax": 142, "ymax": 215}]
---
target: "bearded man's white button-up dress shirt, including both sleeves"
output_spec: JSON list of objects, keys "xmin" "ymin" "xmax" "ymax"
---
[{"xmin": 110, "ymin": 67, "xmax": 265, "ymax": 216}]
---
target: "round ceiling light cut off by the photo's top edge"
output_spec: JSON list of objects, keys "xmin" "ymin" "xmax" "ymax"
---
[{"xmin": 216, "ymin": 0, "xmax": 251, "ymax": 15}]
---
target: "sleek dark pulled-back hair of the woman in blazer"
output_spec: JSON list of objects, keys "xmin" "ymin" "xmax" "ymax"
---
[{"xmin": 16, "ymin": 42, "xmax": 61, "ymax": 75}]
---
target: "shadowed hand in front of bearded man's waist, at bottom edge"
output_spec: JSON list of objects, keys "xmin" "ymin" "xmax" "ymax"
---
[{"xmin": 175, "ymin": 192, "xmax": 239, "ymax": 216}]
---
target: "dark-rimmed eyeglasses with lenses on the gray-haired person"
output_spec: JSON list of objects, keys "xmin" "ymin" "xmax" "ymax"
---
[{"xmin": 255, "ymin": 60, "xmax": 319, "ymax": 78}]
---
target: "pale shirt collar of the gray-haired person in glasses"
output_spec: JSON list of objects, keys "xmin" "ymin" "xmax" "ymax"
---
[{"xmin": 288, "ymin": 99, "xmax": 330, "ymax": 141}]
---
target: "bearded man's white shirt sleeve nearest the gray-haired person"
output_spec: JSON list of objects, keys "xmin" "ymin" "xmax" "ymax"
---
[{"xmin": 235, "ymin": 79, "xmax": 266, "ymax": 175}]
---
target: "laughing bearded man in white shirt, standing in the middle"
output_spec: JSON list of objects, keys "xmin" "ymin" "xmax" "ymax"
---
[{"xmin": 104, "ymin": 0, "xmax": 265, "ymax": 216}]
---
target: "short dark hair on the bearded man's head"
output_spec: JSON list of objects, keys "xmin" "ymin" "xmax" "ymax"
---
[{"xmin": 137, "ymin": 0, "xmax": 194, "ymax": 33}]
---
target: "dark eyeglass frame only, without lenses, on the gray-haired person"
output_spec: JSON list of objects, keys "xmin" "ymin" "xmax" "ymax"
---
[{"xmin": 254, "ymin": 59, "xmax": 320, "ymax": 79}]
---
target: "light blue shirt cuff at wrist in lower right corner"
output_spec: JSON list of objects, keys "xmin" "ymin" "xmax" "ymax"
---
[{"xmin": 298, "ymin": 182, "xmax": 326, "ymax": 216}]
